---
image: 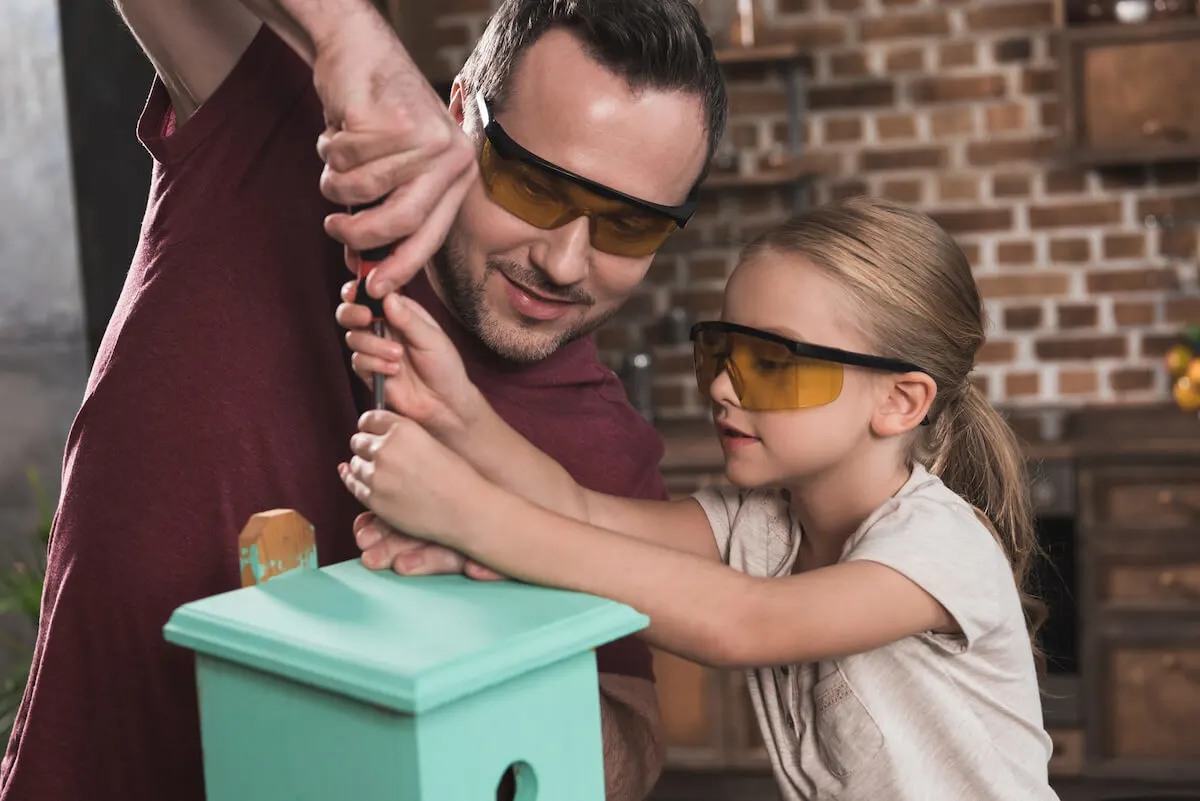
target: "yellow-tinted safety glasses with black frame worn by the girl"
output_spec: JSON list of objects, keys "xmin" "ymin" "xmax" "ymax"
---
[{"xmin": 691, "ymin": 321, "xmax": 929, "ymax": 422}]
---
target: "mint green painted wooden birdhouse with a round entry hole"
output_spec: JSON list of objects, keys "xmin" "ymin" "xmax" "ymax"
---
[{"xmin": 164, "ymin": 513, "xmax": 648, "ymax": 801}]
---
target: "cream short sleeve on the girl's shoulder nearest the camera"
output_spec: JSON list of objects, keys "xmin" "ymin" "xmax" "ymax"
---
[{"xmin": 845, "ymin": 499, "xmax": 1012, "ymax": 652}]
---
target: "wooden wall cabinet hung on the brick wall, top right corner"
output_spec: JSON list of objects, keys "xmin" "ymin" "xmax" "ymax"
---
[{"xmin": 1057, "ymin": 19, "xmax": 1200, "ymax": 164}]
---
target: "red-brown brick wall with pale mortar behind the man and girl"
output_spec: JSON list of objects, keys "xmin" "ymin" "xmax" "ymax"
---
[{"xmin": 427, "ymin": 0, "xmax": 1200, "ymax": 417}]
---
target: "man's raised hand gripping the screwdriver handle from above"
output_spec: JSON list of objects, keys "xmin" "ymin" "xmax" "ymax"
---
[{"xmin": 313, "ymin": 11, "xmax": 478, "ymax": 297}]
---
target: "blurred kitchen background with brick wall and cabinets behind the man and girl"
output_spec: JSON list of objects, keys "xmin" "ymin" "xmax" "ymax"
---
[{"xmin": 0, "ymin": 0, "xmax": 1200, "ymax": 800}]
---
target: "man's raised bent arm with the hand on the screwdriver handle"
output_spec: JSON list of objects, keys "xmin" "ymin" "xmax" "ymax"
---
[{"xmin": 114, "ymin": 0, "xmax": 478, "ymax": 291}]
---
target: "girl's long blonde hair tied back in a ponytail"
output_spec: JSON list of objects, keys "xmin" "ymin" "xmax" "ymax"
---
[{"xmin": 743, "ymin": 195, "xmax": 1045, "ymax": 661}]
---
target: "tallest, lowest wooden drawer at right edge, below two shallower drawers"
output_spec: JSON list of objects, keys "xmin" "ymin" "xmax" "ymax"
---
[{"xmin": 1105, "ymin": 643, "xmax": 1200, "ymax": 761}]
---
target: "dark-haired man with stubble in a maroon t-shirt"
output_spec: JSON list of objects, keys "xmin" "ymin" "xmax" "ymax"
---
[{"xmin": 0, "ymin": 0, "xmax": 725, "ymax": 801}]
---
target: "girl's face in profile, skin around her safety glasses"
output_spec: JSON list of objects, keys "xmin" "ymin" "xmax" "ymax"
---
[{"xmin": 709, "ymin": 252, "xmax": 889, "ymax": 487}]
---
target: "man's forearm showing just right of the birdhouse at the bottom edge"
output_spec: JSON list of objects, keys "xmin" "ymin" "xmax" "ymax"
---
[{"xmin": 600, "ymin": 673, "xmax": 666, "ymax": 801}]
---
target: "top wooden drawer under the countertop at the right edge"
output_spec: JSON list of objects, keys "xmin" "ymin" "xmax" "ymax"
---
[{"xmin": 1080, "ymin": 465, "xmax": 1200, "ymax": 531}]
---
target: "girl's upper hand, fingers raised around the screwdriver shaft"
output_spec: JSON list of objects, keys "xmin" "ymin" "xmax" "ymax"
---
[{"xmin": 337, "ymin": 281, "xmax": 486, "ymax": 442}]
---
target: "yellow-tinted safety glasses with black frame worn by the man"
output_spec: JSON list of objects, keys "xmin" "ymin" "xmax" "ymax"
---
[{"xmin": 475, "ymin": 92, "xmax": 697, "ymax": 258}]
